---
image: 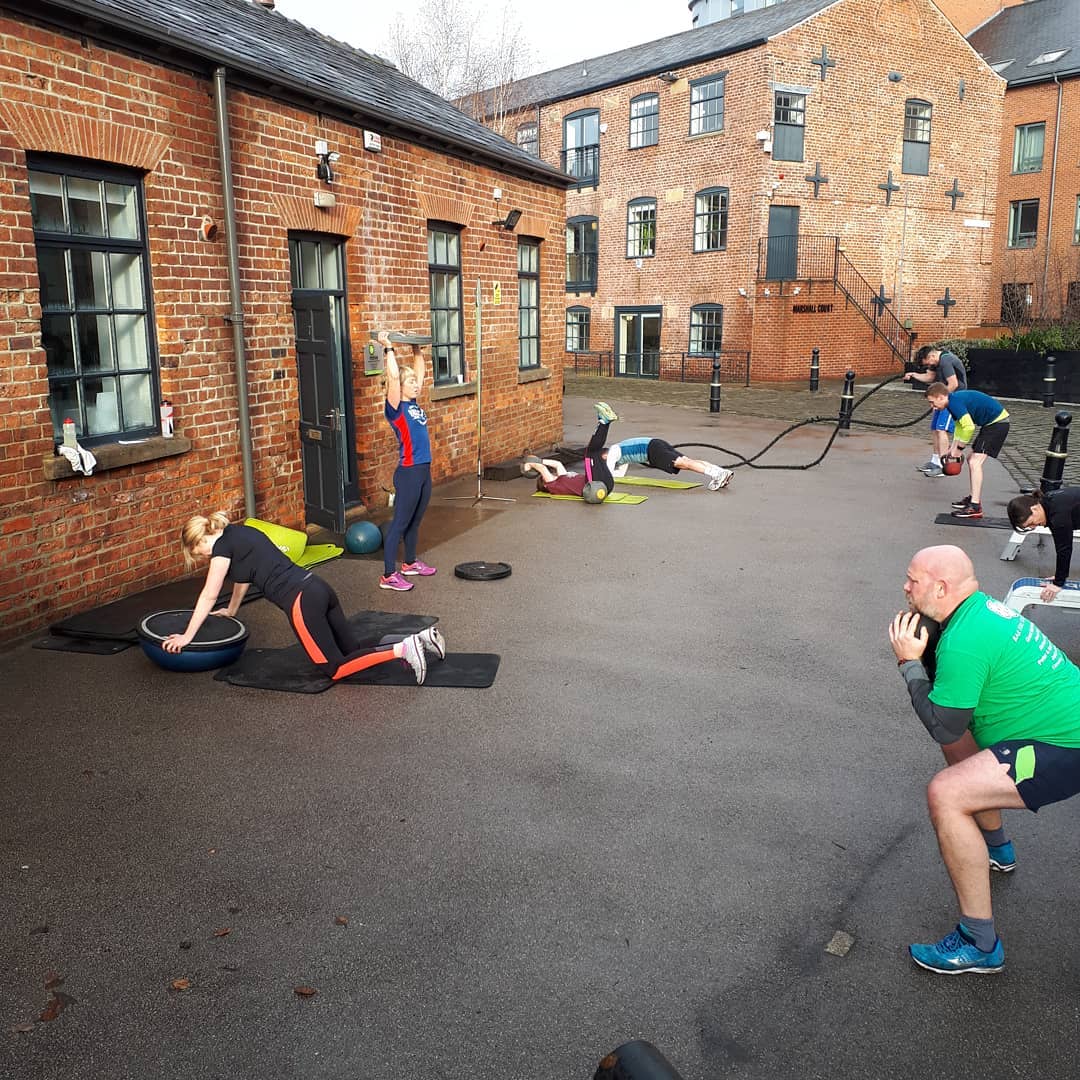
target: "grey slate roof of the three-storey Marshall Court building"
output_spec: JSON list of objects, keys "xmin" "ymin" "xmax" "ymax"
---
[{"xmin": 492, "ymin": 0, "xmax": 839, "ymax": 108}]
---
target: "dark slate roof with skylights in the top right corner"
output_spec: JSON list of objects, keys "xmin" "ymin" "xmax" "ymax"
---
[{"xmin": 968, "ymin": 0, "xmax": 1080, "ymax": 86}]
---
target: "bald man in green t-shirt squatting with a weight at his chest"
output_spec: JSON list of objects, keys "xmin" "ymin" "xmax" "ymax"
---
[{"xmin": 889, "ymin": 545, "xmax": 1080, "ymax": 975}]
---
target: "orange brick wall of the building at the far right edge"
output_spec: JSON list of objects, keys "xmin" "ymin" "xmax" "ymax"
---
[{"xmin": 987, "ymin": 78, "xmax": 1080, "ymax": 323}]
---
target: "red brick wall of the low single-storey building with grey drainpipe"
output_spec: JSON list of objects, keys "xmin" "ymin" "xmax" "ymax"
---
[{"xmin": 0, "ymin": 19, "xmax": 565, "ymax": 640}]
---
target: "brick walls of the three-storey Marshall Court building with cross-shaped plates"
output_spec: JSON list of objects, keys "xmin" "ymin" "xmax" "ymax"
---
[{"xmin": 496, "ymin": 0, "xmax": 1004, "ymax": 378}]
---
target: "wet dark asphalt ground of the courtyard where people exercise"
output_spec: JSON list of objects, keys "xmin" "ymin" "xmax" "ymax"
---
[{"xmin": 0, "ymin": 379, "xmax": 1080, "ymax": 1080}]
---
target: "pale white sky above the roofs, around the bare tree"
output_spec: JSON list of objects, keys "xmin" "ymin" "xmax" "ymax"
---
[{"xmin": 276, "ymin": 0, "xmax": 691, "ymax": 75}]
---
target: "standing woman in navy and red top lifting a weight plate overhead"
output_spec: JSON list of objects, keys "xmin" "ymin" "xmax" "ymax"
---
[{"xmin": 379, "ymin": 330, "xmax": 435, "ymax": 593}]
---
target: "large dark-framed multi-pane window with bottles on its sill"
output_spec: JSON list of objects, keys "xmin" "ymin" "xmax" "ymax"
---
[{"xmin": 27, "ymin": 154, "xmax": 161, "ymax": 446}]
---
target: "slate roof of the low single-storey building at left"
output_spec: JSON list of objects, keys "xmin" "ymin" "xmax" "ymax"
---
[{"xmin": 24, "ymin": 0, "xmax": 570, "ymax": 186}]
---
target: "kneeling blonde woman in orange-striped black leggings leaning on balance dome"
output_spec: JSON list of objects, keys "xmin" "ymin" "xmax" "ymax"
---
[{"xmin": 162, "ymin": 511, "xmax": 446, "ymax": 684}]
